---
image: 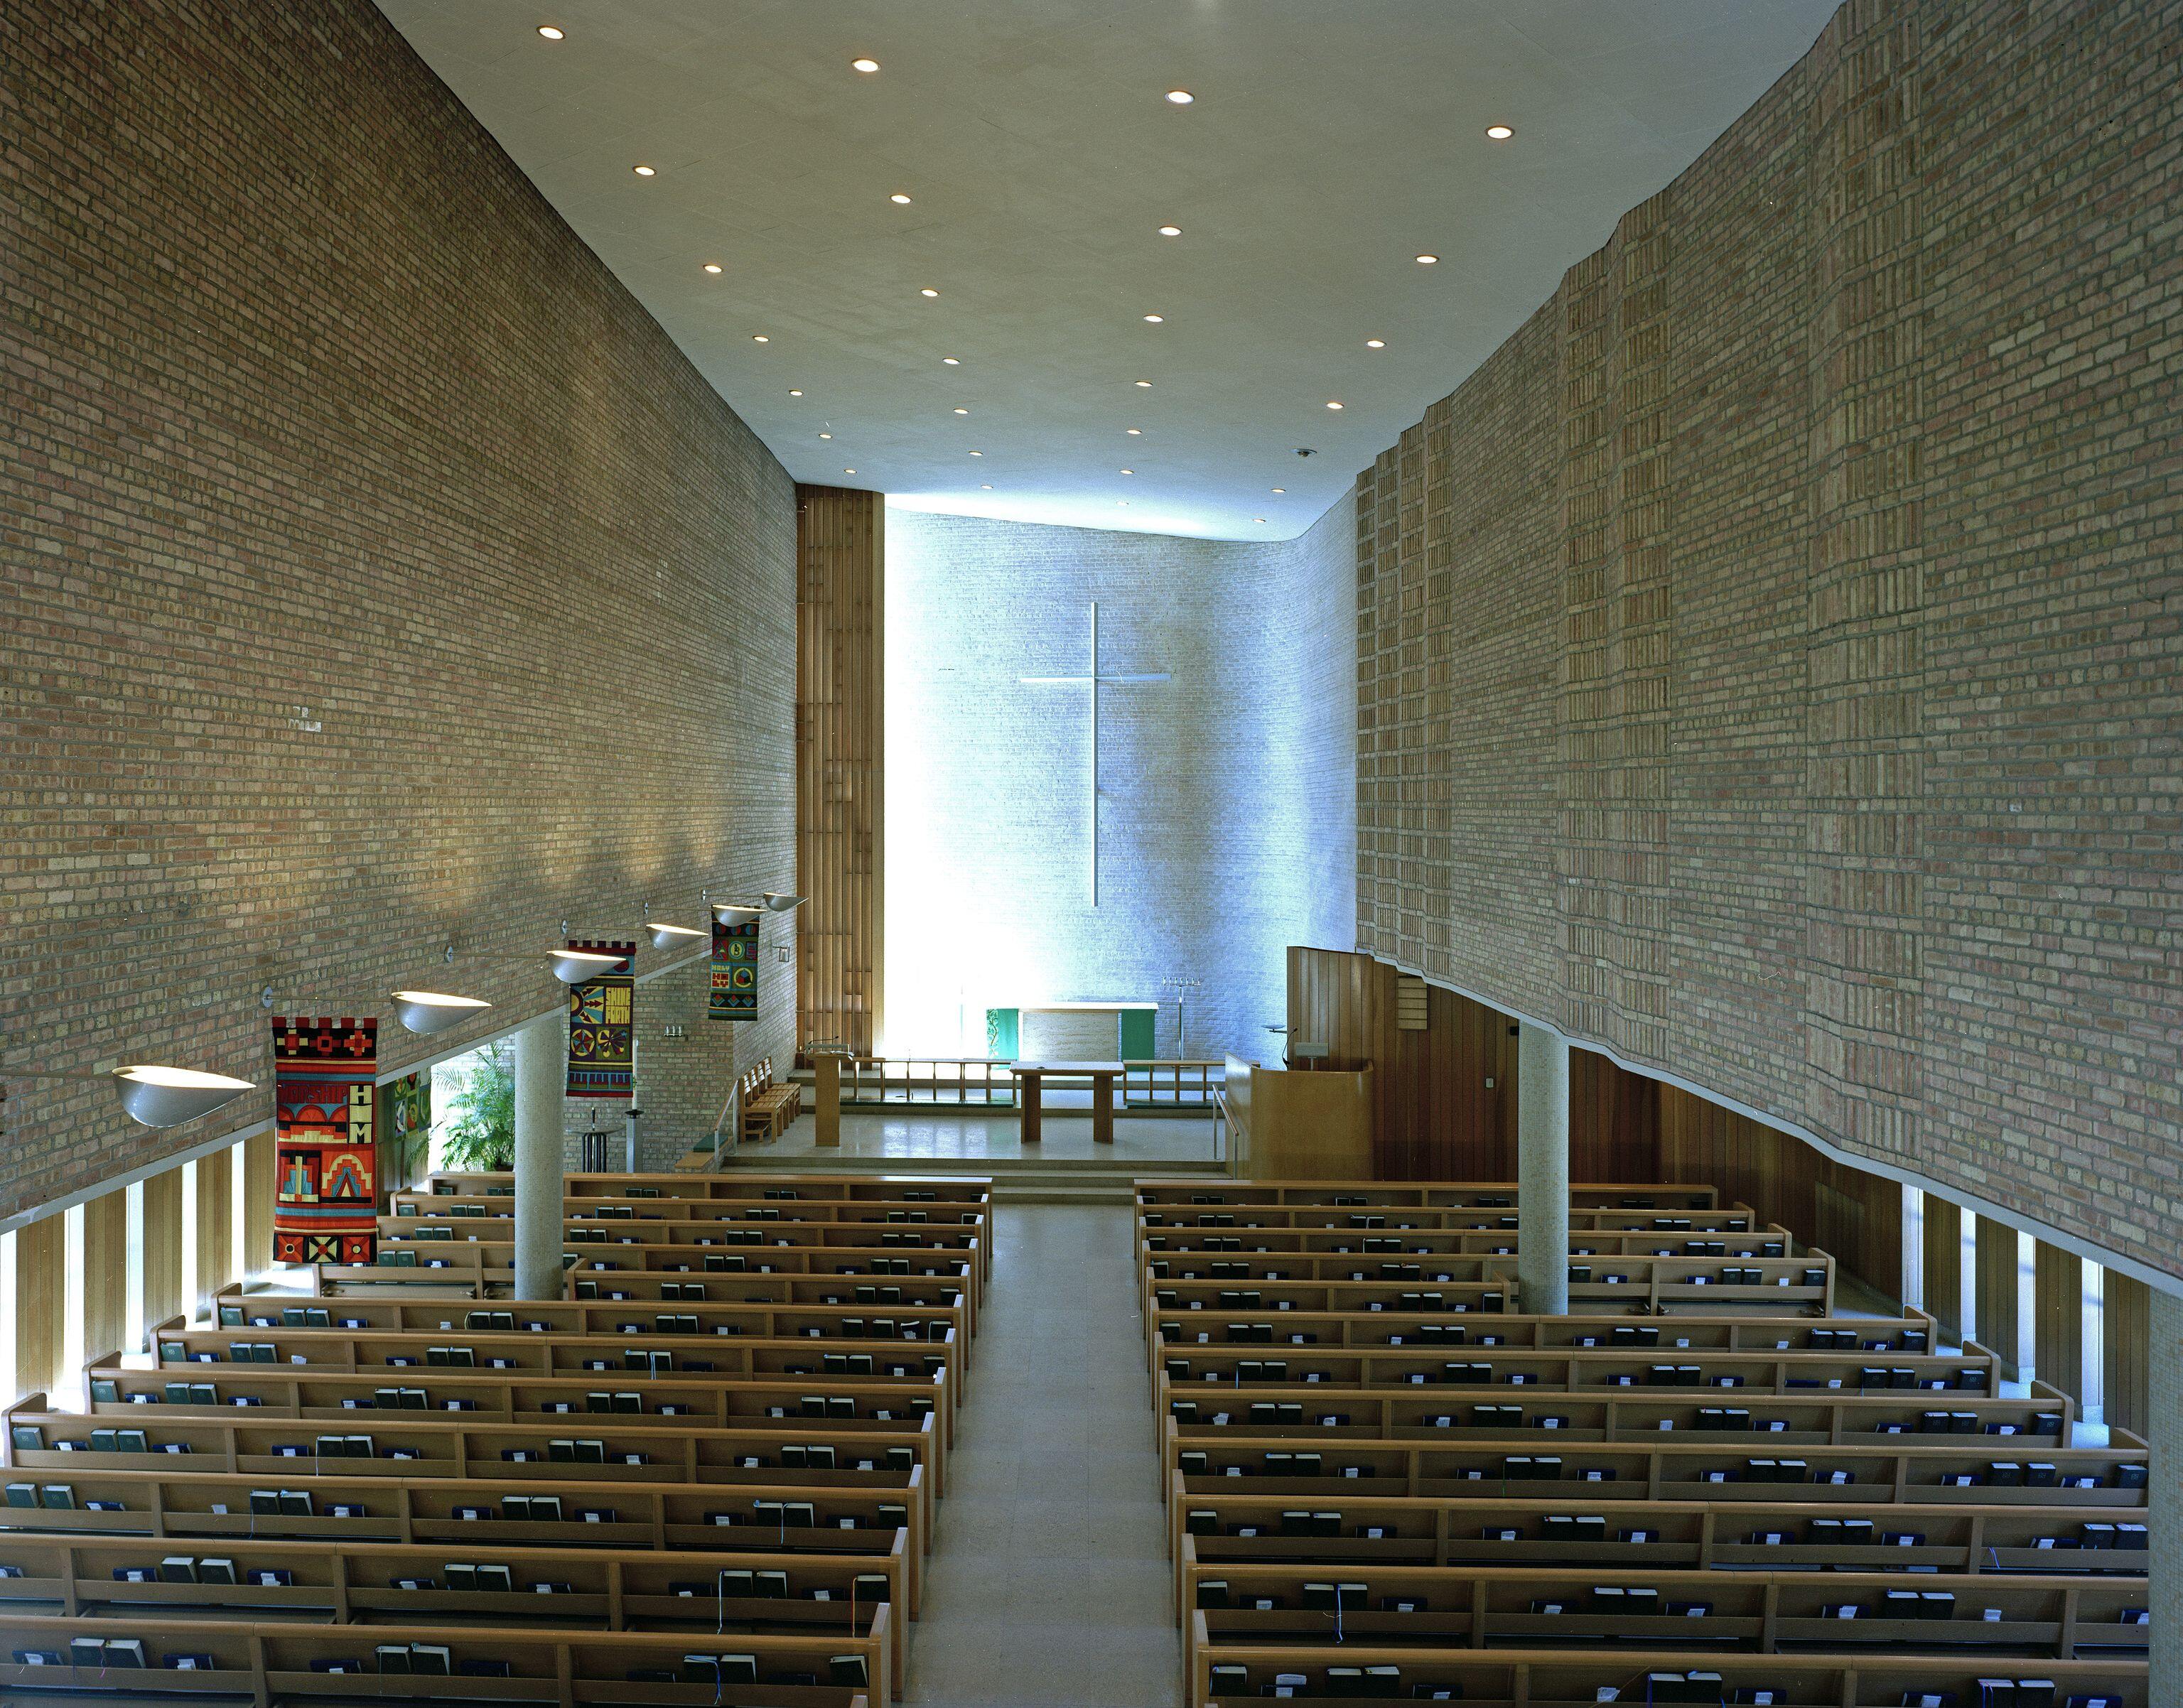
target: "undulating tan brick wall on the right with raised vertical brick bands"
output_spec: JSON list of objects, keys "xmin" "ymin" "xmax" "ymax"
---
[{"xmin": 1358, "ymin": 0, "xmax": 2183, "ymax": 1272}]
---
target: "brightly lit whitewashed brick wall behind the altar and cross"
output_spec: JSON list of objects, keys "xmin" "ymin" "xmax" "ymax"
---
[{"xmin": 886, "ymin": 497, "xmax": 1356, "ymax": 1058}]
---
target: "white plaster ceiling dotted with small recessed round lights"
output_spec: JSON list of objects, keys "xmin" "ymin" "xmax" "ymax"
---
[{"xmin": 380, "ymin": 0, "xmax": 1833, "ymax": 539}]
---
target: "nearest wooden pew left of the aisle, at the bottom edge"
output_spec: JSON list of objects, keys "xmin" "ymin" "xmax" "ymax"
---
[{"xmin": 0, "ymin": 1608, "xmax": 890, "ymax": 1708}]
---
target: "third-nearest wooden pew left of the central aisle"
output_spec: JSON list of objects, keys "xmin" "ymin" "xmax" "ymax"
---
[{"xmin": 0, "ymin": 1468, "xmax": 930, "ymax": 1618}]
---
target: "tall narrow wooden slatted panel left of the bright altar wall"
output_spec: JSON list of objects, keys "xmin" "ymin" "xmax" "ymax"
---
[{"xmin": 797, "ymin": 487, "xmax": 886, "ymax": 1054}]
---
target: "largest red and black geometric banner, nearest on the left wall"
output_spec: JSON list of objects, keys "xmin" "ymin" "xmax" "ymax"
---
[{"xmin": 273, "ymin": 1017, "xmax": 380, "ymax": 1263}]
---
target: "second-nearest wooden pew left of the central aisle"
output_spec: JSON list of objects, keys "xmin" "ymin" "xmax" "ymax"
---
[{"xmin": 0, "ymin": 1529, "xmax": 904, "ymax": 1697}]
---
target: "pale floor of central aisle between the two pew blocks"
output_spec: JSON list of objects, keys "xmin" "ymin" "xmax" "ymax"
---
[{"xmin": 906, "ymin": 1204, "xmax": 1183, "ymax": 1708}]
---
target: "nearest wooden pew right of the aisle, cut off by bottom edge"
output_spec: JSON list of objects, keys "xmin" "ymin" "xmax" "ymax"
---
[{"xmin": 1187, "ymin": 1643, "xmax": 2146, "ymax": 1708}]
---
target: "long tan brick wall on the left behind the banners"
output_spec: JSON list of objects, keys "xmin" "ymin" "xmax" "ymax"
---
[{"xmin": 0, "ymin": 0, "xmax": 794, "ymax": 1213}]
